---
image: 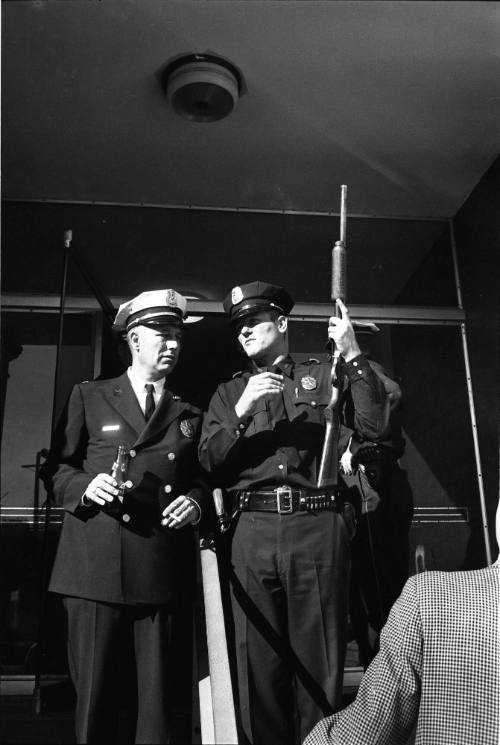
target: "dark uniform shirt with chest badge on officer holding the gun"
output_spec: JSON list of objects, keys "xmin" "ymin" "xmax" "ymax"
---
[{"xmin": 199, "ymin": 355, "xmax": 386, "ymax": 490}]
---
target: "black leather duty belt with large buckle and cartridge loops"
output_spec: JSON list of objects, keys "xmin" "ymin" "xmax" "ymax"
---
[{"xmin": 237, "ymin": 486, "xmax": 341, "ymax": 515}]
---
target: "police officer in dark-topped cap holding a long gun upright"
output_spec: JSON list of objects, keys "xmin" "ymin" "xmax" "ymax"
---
[{"xmin": 199, "ymin": 282, "xmax": 385, "ymax": 745}]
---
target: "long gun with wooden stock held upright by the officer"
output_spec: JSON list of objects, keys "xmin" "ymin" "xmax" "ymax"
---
[{"xmin": 318, "ymin": 185, "xmax": 347, "ymax": 488}]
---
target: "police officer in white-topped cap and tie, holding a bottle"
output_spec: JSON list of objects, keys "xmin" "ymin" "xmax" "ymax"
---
[{"xmin": 44, "ymin": 289, "xmax": 204, "ymax": 743}]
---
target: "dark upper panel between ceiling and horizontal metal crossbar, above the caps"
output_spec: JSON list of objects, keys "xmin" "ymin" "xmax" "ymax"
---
[{"xmin": 2, "ymin": 202, "xmax": 453, "ymax": 305}]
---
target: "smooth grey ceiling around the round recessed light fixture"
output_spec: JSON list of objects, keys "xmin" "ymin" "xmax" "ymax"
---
[{"xmin": 2, "ymin": 0, "xmax": 500, "ymax": 217}]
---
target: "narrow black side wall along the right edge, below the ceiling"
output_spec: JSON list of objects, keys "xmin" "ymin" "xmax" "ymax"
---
[{"xmin": 454, "ymin": 158, "xmax": 500, "ymax": 546}]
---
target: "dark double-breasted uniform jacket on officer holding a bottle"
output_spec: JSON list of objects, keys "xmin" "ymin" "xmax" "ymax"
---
[{"xmin": 44, "ymin": 374, "xmax": 204, "ymax": 604}]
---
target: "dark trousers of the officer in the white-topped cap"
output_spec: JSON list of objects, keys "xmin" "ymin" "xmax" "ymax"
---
[{"xmin": 63, "ymin": 597, "xmax": 171, "ymax": 743}]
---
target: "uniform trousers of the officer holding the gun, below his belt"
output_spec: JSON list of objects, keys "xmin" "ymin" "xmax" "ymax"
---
[{"xmin": 230, "ymin": 511, "xmax": 350, "ymax": 745}]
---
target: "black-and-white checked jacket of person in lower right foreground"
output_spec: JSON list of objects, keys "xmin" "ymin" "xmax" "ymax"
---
[{"xmin": 304, "ymin": 561, "xmax": 500, "ymax": 745}]
